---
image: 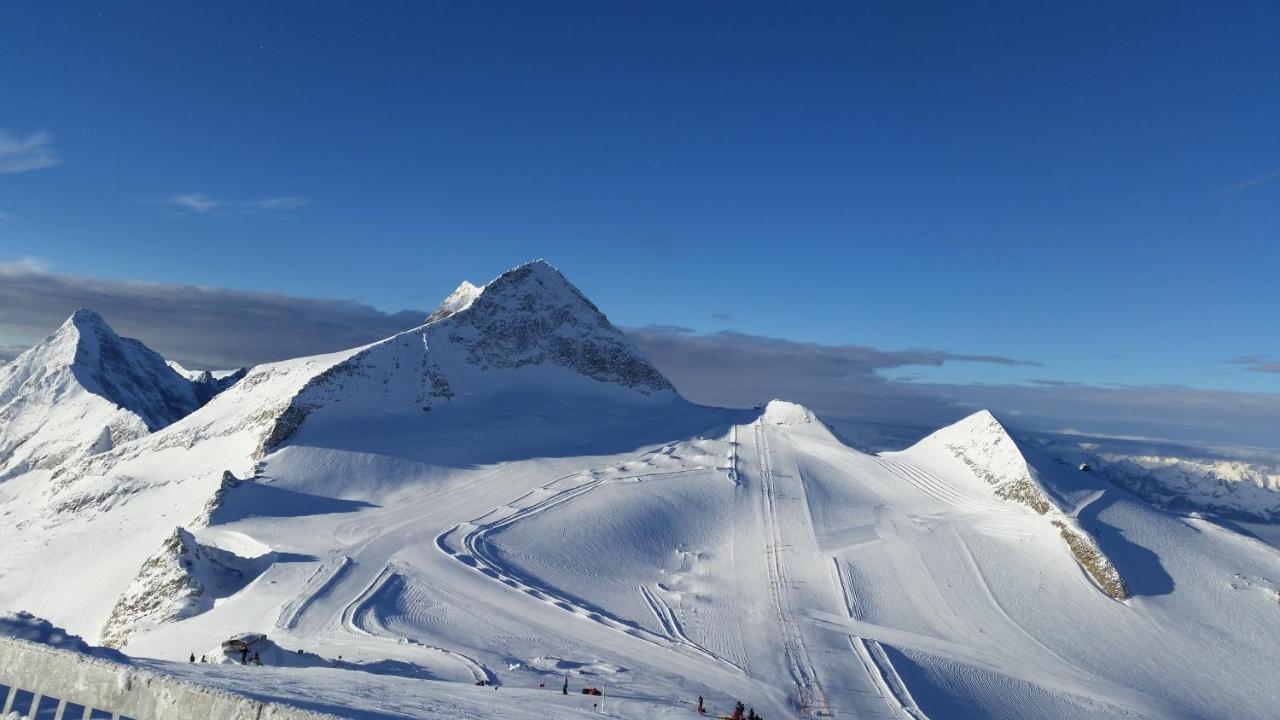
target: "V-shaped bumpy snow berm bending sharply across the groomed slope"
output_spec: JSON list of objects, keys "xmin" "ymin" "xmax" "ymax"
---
[{"xmin": 435, "ymin": 468, "xmax": 742, "ymax": 673}]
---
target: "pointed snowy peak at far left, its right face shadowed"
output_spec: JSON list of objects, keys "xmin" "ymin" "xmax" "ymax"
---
[{"xmin": 0, "ymin": 310, "xmax": 204, "ymax": 479}]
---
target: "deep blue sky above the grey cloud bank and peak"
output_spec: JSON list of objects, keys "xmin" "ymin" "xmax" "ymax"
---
[{"xmin": 0, "ymin": 1, "xmax": 1280, "ymax": 391}]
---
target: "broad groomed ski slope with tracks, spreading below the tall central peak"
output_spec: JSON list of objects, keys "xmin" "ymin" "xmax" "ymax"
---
[{"xmin": 99, "ymin": 394, "xmax": 1280, "ymax": 717}]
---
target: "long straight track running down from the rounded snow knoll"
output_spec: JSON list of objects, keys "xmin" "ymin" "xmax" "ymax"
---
[{"xmin": 753, "ymin": 420, "xmax": 827, "ymax": 715}]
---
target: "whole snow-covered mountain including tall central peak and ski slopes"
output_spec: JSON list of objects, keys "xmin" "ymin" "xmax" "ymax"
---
[{"xmin": 0, "ymin": 263, "xmax": 1280, "ymax": 720}]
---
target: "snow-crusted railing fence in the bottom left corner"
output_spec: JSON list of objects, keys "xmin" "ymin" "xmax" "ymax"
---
[{"xmin": 0, "ymin": 637, "xmax": 338, "ymax": 720}]
